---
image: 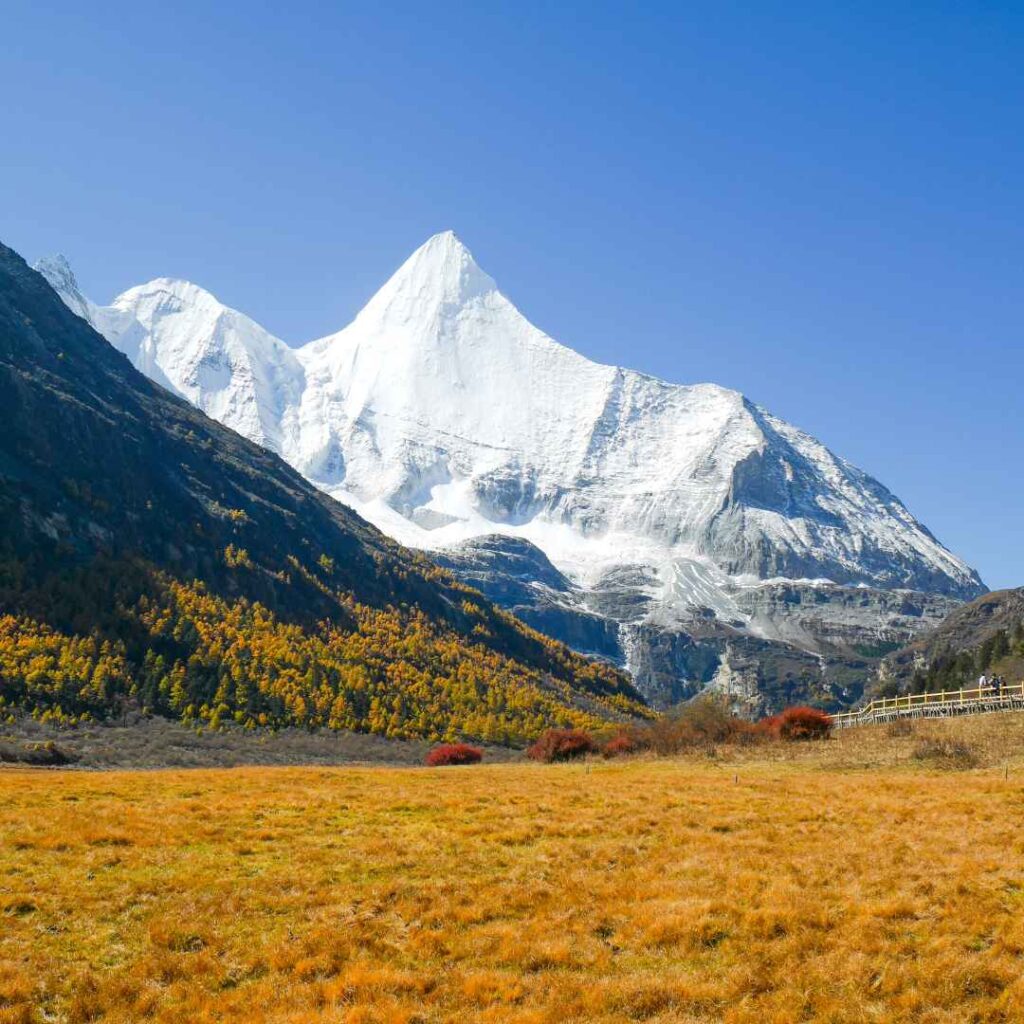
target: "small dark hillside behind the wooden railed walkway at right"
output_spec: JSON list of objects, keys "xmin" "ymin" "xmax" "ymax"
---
[{"xmin": 878, "ymin": 587, "xmax": 1024, "ymax": 693}]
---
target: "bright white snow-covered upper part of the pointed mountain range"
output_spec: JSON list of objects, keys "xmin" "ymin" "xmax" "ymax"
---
[{"xmin": 37, "ymin": 231, "xmax": 984, "ymax": 708}]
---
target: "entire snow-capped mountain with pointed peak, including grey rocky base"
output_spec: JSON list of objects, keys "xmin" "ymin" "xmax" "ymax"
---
[{"xmin": 38, "ymin": 231, "xmax": 984, "ymax": 710}]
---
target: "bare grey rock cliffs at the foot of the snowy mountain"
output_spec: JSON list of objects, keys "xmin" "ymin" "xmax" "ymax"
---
[{"xmin": 435, "ymin": 535, "xmax": 958, "ymax": 715}]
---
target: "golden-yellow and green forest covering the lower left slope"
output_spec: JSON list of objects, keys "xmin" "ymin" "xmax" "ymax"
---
[{"xmin": 0, "ymin": 550, "xmax": 645, "ymax": 744}]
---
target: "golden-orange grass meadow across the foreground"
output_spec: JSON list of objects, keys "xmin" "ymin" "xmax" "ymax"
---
[{"xmin": 0, "ymin": 716, "xmax": 1024, "ymax": 1024}]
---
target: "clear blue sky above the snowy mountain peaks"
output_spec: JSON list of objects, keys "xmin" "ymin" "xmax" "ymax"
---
[{"xmin": 0, "ymin": 0, "xmax": 1024, "ymax": 588}]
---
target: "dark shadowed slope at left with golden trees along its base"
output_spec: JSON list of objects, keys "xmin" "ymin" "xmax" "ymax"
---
[{"xmin": 0, "ymin": 246, "xmax": 643, "ymax": 742}]
